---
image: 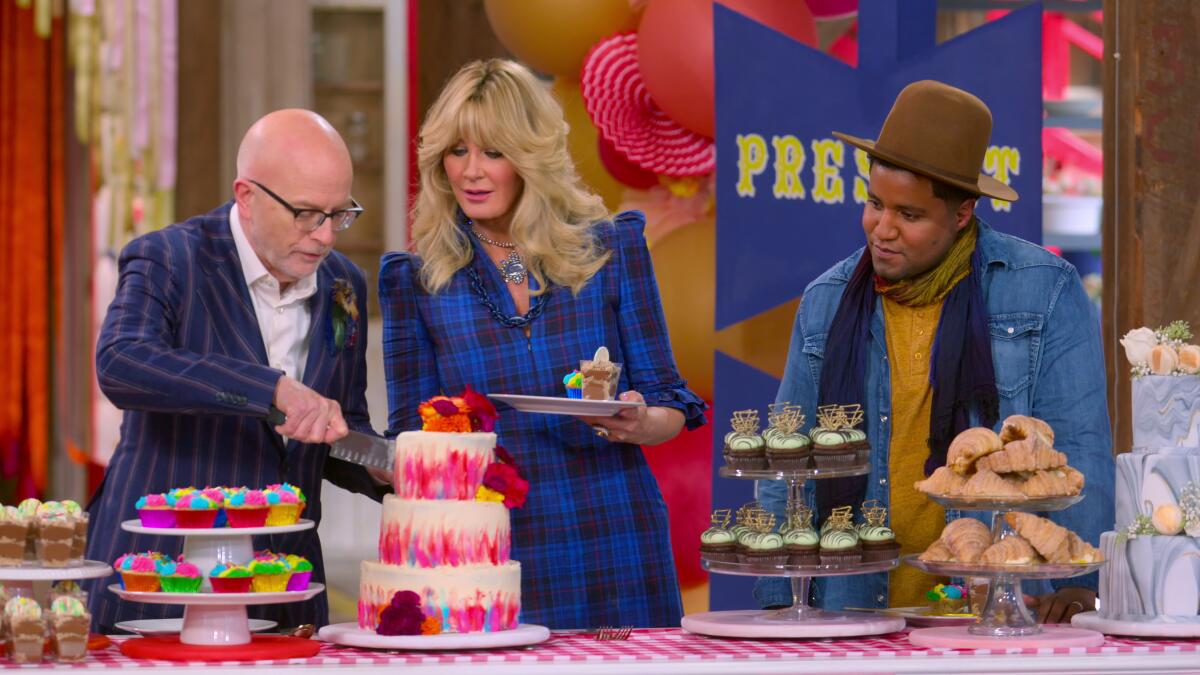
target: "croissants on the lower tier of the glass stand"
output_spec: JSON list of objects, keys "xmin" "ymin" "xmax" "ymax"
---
[{"xmin": 918, "ymin": 512, "xmax": 1104, "ymax": 565}]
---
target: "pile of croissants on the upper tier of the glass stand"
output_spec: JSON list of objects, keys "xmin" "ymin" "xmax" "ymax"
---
[{"xmin": 914, "ymin": 414, "xmax": 1084, "ymax": 502}]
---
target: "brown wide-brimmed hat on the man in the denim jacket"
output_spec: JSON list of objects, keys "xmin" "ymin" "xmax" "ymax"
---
[{"xmin": 833, "ymin": 79, "xmax": 1018, "ymax": 202}]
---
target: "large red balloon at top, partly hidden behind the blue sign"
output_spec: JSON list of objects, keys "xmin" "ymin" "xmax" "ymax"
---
[{"xmin": 637, "ymin": 0, "xmax": 817, "ymax": 138}]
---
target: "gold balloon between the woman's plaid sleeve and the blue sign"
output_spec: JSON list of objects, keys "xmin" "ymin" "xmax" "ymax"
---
[{"xmin": 650, "ymin": 217, "xmax": 716, "ymax": 401}]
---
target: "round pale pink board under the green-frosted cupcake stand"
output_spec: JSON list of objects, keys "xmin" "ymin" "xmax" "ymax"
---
[{"xmin": 679, "ymin": 609, "xmax": 904, "ymax": 638}]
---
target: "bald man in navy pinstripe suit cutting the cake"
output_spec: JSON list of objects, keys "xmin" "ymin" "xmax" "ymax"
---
[{"xmin": 88, "ymin": 109, "xmax": 389, "ymax": 632}]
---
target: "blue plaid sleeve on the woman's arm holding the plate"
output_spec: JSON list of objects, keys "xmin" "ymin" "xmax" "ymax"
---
[{"xmin": 608, "ymin": 211, "xmax": 708, "ymax": 429}]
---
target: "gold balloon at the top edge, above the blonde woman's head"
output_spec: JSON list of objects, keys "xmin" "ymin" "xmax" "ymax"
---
[{"xmin": 484, "ymin": 0, "xmax": 637, "ymax": 79}]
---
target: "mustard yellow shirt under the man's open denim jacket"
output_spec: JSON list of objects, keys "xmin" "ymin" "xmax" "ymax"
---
[{"xmin": 883, "ymin": 297, "xmax": 946, "ymax": 607}]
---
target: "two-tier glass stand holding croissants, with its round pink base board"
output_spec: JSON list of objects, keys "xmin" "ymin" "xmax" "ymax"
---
[{"xmin": 904, "ymin": 495, "xmax": 1104, "ymax": 649}]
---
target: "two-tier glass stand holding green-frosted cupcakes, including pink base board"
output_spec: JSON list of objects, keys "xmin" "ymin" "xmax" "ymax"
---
[{"xmin": 680, "ymin": 454, "xmax": 905, "ymax": 638}]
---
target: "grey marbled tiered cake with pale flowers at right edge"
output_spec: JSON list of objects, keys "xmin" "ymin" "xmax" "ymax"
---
[{"xmin": 1099, "ymin": 330, "xmax": 1200, "ymax": 622}]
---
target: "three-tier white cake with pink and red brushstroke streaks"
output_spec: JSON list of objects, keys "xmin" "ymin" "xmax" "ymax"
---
[{"xmin": 359, "ymin": 391, "xmax": 524, "ymax": 633}]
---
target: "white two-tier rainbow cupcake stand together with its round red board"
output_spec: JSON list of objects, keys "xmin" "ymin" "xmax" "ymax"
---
[{"xmin": 108, "ymin": 520, "xmax": 325, "ymax": 658}]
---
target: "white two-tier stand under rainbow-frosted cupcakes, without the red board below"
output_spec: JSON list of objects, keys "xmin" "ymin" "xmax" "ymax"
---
[{"xmin": 118, "ymin": 520, "xmax": 325, "ymax": 645}]
